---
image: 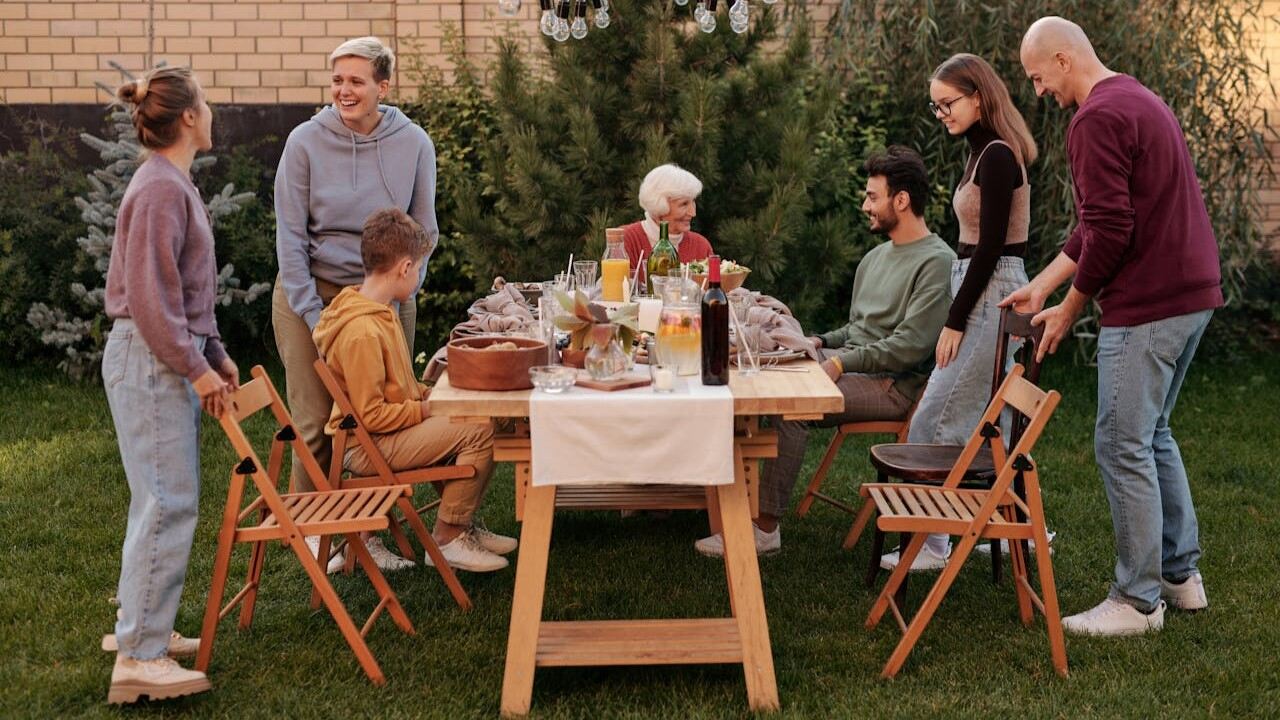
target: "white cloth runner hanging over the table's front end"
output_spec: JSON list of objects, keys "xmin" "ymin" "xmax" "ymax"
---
[{"xmin": 529, "ymin": 366, "xmax": 733, "ymax": 486}]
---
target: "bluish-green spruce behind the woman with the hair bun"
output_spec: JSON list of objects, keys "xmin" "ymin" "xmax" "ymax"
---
[{"xmin": 27, "ymin": 65, "xmax": 271, "ymax": 379}]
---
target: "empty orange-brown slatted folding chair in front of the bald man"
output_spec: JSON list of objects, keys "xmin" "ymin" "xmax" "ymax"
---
[{"xmin": 852, "ymin": 365, "xmax": 1068, "ymax": 678}]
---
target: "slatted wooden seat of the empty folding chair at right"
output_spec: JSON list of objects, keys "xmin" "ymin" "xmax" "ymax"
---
[{"xmin": 860, "ymin": 483, "xmax": 1032, "ymax": 538}]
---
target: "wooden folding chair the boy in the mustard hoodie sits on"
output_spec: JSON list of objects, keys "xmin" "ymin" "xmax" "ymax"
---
[{"xmin": 311, "ymin": 357, "xmax": 476, "ymax": 610}]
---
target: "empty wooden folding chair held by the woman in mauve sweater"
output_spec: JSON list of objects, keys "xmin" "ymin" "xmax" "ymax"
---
[{"xmin": 196, "ymin": 365, "xmax": 416, "ymax": 685}]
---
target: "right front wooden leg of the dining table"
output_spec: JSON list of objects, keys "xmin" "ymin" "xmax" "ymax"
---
[{"xmin": 716, "ymin": 443, "xmax": 778, "ymax": 710}]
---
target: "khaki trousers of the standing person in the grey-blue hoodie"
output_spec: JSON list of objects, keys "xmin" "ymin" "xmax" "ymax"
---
[{"xmin": 271, "ymin": 277, "xmax": 417, "ymax": 492}]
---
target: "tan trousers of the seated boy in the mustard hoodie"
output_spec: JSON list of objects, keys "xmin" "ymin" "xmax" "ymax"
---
[{"xmin": 346, "ymin": 416, "xmax": 493, "ymax": 525}]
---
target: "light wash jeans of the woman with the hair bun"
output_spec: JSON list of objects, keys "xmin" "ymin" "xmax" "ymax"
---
[{"xmin": 102, "ymin": 319, "xmax": 205, "ymax": 660}]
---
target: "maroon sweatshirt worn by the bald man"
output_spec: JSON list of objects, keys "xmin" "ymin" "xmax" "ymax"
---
[{"xmin": 1062, "ymin": 76, "xmax": 1222, "ymax": 327}]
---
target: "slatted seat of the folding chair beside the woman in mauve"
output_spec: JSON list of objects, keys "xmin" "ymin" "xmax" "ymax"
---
[{"xmin": 236, "ymin": 486, "xmax": 412, "ymax": 542}]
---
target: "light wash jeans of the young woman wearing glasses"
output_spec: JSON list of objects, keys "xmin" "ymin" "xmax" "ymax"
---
[{"xmin": 906, "ymin": 258, "xmax": 1028, "ymax": 556}]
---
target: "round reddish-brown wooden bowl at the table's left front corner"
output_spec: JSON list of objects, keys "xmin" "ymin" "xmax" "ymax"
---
[{"xmin": 445, "ymin": 336, "xmax": 547, "ymax": 389}]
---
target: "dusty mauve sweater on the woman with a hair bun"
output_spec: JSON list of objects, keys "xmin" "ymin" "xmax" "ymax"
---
[{"xmin": 106, "ymin": 155, "xmax": 227, "ymax": 382}]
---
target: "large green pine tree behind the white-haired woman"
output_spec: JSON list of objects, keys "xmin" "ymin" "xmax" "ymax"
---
[{"xmin": 458, "ymin": 0, "xmax": 860, "ymax": 325}]
